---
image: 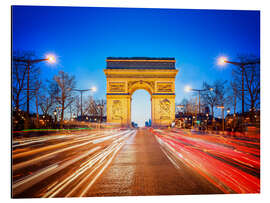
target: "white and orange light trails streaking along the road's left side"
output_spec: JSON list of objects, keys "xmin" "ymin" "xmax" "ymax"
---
[{"xmin": 12, "ymin": 129, "xmax": 136, "ymax": 197}]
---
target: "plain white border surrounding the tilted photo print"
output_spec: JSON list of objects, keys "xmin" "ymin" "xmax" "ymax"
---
[{"xmin": 0, "ymin": 0, "xmax": 270, "ymax": 203}]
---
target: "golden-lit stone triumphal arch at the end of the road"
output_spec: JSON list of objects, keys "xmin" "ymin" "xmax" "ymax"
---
[{"xmin": 104, "ymin": 57, "xmax": 178, "ymax": 127}]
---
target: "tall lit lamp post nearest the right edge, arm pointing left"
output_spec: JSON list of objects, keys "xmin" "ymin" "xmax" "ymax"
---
[{"xmin": 218, "ymin": 57, "xmax": 260, "ymax": 130}]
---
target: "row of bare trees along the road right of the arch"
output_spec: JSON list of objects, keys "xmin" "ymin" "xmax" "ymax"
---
[{"xmin": 179, "ymin": 56, "xmax": 260, "ymax": 122}]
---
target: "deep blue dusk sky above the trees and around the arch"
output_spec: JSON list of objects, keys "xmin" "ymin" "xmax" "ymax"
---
[{"xmin": 12, "ymin": 6, "xmax": 260, "ymax": 125}]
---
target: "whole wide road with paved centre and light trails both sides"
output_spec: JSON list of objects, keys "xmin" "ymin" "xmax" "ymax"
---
[{"xmin": 12, "ymin": 129, "xmax": 260, "ymax": 198}]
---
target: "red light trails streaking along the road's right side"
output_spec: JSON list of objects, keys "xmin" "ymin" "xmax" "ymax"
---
[{"xmin": 151, "ymin": 130, "xmax": 260, "ymax": 193}]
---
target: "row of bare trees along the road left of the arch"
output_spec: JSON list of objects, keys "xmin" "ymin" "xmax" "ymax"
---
[{"xmin": 12, "ymin": 51, "xmax": 105, "ymax": 130}]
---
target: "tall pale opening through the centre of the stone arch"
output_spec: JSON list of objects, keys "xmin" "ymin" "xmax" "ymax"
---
[{"xmin": 131, "ymin": 89, "xmax": 152, "ymax": 127}]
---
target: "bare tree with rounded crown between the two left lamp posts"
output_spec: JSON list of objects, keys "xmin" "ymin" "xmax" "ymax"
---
[{"xmin": 51, "ymin": 71, "xmax": 75, "ymax": 128}]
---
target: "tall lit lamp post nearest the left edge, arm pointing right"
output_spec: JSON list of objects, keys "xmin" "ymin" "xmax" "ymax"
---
[{"xmin": 13, "ymin": 55, "xmax": 56, "ymax": 128}]
